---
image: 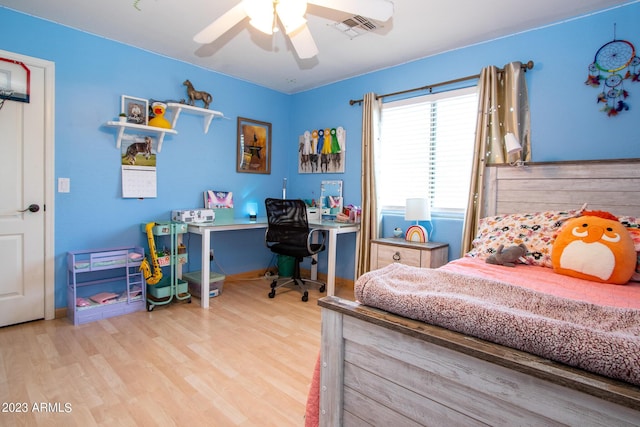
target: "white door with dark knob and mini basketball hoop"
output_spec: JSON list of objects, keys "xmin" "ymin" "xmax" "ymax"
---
[{"xmin": 0, "ymin": 51, "xmax": 53, "ymax": 326}]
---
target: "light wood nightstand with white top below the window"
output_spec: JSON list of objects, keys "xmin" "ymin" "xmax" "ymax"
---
[{"xmin": 370, "ymin": 237, "xmax": 449, "ymax": 270}]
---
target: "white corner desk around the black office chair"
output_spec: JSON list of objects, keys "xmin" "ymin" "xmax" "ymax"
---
[{"xmin": 187, "ymin": 218, "xmax": 360, "ymax": 308}]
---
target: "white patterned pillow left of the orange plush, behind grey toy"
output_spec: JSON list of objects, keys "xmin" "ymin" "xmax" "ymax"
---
[{"xmin": 467, "ymin": 207, "xmax": 584, "ymax": 268}]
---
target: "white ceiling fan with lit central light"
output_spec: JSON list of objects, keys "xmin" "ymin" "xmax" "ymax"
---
[{"xmin": 193, "ymin": 0, "xmax": 393, "ymax": 59}]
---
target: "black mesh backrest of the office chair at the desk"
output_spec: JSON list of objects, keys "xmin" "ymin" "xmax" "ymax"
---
[{"xmin": 264, "ymin": 198, "xmax": 309, "ymax": 247}]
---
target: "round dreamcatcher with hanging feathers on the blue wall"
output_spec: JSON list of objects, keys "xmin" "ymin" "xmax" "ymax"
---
[{"xmin": 585, "ymin": 27, "xmax": 640, "ymax": 117}]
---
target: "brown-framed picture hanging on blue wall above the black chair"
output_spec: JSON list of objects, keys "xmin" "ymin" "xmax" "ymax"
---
[{"xmin": 236, "ymin": 117, "xmax": 271, "ymax": 174}]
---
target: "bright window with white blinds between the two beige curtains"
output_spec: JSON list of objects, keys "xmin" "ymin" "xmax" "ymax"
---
[{"xmin": 376, "ymin": 86, "xmax": 478, "ymax": 213}]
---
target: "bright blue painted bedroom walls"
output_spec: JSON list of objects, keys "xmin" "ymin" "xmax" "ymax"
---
[{"xmin": 0, "ymin": 2, "xmax": 640, "ymax": 307}]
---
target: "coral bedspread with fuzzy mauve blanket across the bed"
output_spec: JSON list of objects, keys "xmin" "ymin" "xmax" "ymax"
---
[{"xmin": 354, "ymin": 258, "xmax": 640, "ymax": 385}]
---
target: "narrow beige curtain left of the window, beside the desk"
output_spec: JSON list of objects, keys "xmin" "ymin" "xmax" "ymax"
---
[{"xmin": 356, "ymin": 93, "xmax": 382, "ymax": 279}]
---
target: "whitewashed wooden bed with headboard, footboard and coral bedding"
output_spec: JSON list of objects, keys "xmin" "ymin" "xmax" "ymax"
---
[{"xmin": 307, "ymin": 159, "xmax": 640, "ymax": 426}]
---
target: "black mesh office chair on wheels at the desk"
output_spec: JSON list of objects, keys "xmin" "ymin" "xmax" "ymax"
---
[{"xmin": 264, "ymin": 198, "xmax": 327, "ymax": 301}]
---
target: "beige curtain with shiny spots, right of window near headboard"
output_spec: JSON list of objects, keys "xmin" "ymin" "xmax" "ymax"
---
[{"xmin": 461, "ymin": 62, "xmax": 531, "ymax": 256}]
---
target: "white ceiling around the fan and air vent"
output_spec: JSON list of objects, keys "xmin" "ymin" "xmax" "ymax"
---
[{"xmin": 0, "ymin": 0, "xmax": 633, "ymax": 93}]
